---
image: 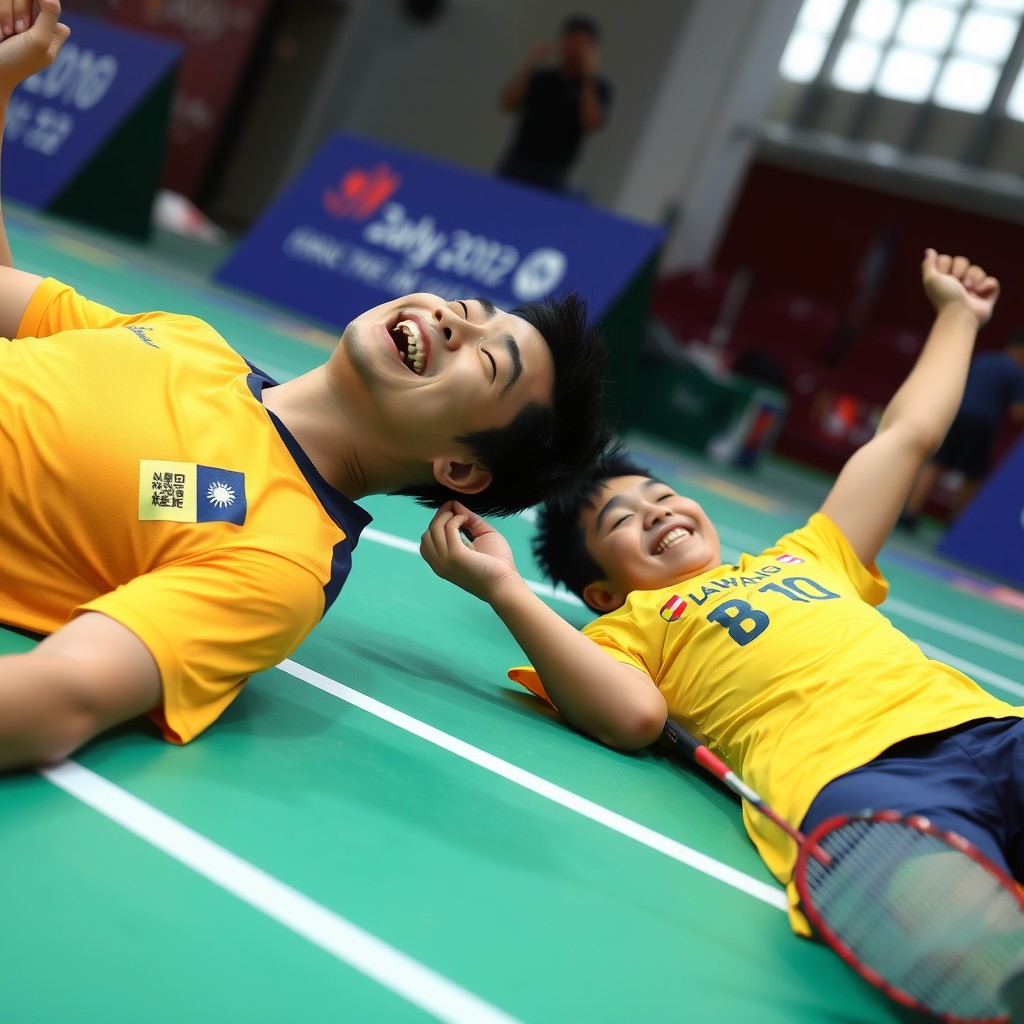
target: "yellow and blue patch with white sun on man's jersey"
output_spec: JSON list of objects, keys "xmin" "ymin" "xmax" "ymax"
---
[{"xmin": 138, "ymin": 459, "xmax": 246, "ymax": 526}]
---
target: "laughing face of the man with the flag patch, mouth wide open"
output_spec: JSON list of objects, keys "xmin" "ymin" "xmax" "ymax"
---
[{"xmin": 331, "ymin": 293, "xmax": 554, "ymax": 461}]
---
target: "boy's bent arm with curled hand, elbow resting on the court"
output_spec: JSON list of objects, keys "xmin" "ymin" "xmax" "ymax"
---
[{"xmin": 420, "ymin": 502, "xmax": 668, "ymax": 751}]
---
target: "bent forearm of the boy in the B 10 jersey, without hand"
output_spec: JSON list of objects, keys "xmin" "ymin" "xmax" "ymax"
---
[{"xmin": 490, "ymin": 581, "xmax": 668, "ymax": 750}]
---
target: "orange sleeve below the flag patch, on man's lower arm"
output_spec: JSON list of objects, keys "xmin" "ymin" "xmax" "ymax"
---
[{"xmin": 76, "ymin": 549, "xmax": 325, "ymax": 743}]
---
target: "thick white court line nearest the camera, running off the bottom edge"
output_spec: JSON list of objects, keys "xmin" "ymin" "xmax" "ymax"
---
[{"xmin": 38, "ymin": 761, "xmax": 519, "ymax": 1024}]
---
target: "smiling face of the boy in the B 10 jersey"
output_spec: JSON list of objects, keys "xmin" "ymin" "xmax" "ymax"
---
[{"xmin": 580, "ymin": 476, "xmax": 722, "ymax": 611}]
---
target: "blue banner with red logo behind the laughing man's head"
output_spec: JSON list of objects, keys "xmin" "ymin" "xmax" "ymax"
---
[{"xmin": 216, "ymin": 133, "xmax": 662, "ymax": 325}]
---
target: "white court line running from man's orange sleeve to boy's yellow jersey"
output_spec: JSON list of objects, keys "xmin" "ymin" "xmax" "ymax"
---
[{"xmin": 278, "ymin": 659, "xmax": 786, "ymax": 910}]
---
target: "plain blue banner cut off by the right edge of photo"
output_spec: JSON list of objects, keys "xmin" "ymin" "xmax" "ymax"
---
[{"xmin": 939, "ymin": 438, "xmax": 1024, "ymax": 587}]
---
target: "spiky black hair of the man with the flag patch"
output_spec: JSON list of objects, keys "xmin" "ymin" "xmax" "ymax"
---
[{"xmin": 395, "ymin": 292, "xmax": 610, "ymax": 516}]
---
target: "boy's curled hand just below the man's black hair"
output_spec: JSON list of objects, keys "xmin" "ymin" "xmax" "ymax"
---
[{"xmin": 420, "ymin": 502, "xmax": 520, "ymax": 604}]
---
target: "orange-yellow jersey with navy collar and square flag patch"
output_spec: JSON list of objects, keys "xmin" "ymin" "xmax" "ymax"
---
[{"xmin": 0, "ymin": 280, "xmax": 370, "ymax": 742}]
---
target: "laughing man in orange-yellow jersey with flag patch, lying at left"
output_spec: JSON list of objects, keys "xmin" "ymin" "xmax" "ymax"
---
[{"xmin": 0, "ymin": 0, "xmax": 607, "ymax": 769}]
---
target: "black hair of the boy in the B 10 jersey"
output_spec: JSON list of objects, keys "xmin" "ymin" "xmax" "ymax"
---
[{"xmin": 534, "ymin": 444, "xmax": 651, "ymax": 611}]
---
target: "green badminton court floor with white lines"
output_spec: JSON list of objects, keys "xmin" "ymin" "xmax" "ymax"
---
[{"xmin": 0, "ymin": 209, "xmax": 1024, "ymax": 1024}]
